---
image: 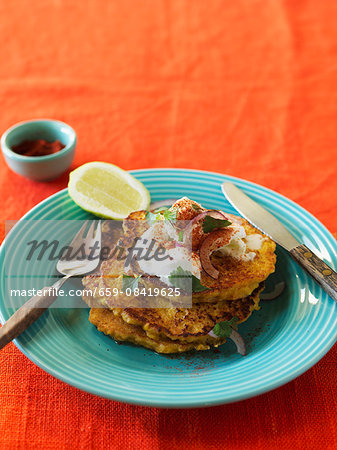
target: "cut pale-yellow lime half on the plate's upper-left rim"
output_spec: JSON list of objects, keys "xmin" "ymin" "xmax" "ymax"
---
[{"xmin": 68, "ymin": 161, "xmax": 150, "ymax": 219}]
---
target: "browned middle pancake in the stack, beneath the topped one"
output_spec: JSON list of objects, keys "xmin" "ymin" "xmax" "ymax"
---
[{"xmin": 112, "ymin": 283, "xmax": 264, "ymax": 342}]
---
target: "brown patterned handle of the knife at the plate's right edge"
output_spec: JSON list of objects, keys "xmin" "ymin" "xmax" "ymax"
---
[{"xmin": 290, "ymin": 244, "xmax": 337, "ymax": 302}]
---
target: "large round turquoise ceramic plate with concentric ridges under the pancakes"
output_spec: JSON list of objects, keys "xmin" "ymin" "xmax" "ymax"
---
[{"xmin": 0, "ymin": 169, "xmax": 337, "ymax": 407}]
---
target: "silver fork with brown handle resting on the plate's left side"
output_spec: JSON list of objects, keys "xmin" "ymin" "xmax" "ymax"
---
[{"xmin": 0, "ymin": 220, "xmax": 101, "ymax": 350}]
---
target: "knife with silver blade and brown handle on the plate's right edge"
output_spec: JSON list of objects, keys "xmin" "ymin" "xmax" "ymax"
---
[{"xmin": 221, "ymin": 182, "xmax": 337, "ymax": 302}]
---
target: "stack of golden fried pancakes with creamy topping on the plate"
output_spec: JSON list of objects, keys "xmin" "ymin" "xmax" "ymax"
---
[{"xmin": 82, "ymin": 198, "xmax": 276, "ymax": 353}]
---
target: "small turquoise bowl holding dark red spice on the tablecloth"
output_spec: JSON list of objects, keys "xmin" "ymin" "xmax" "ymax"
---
[{"xmin": 1, "ymin": 119, "xmax": 77, "ymax": 181}]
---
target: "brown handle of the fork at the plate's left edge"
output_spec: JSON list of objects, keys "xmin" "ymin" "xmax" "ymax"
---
[{"xmin": 0, "ymin": 286, "xmax": 57, "ymax": 350}]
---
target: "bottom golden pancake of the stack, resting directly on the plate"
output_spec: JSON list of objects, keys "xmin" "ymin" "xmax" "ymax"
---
[{"xmin": 89, "ymin": 308, "xmax": 226, "ymax": 353}]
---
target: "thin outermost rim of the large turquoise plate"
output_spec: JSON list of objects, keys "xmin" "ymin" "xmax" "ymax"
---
[{"xmin": 0, "ymin": 167, "xmax": 337, "ymax": 408}]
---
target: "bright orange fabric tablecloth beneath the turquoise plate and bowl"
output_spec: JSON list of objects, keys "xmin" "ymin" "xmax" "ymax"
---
[{"xmin": 0, "ymin": 0, "xmax": 337, "ymax": 449}]
